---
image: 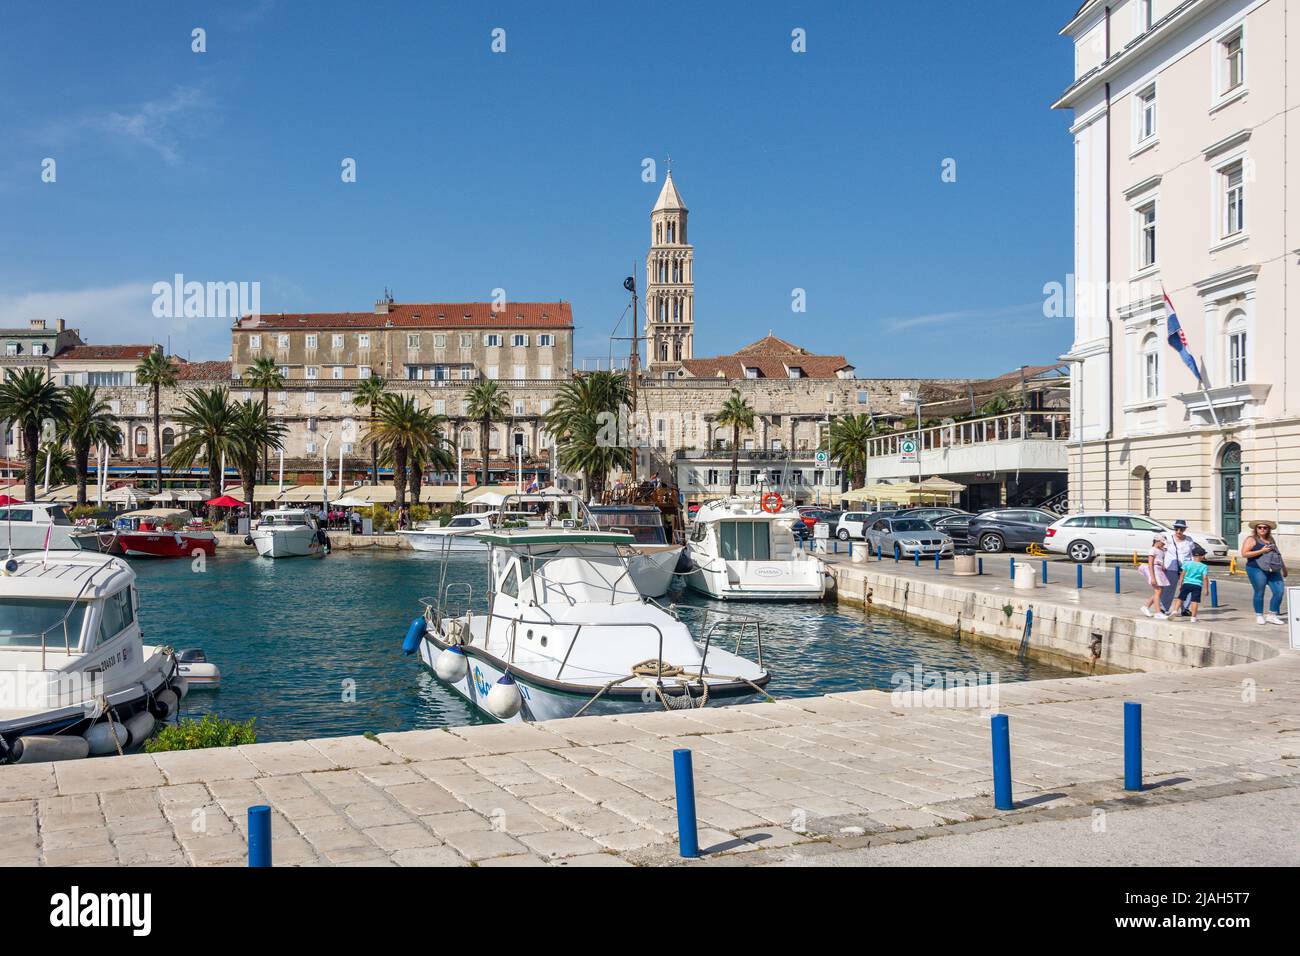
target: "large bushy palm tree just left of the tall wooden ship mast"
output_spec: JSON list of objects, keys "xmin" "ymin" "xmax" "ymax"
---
[{"xmin": 545, "ymin": 372, "xmax": 632, "ymax": 499}]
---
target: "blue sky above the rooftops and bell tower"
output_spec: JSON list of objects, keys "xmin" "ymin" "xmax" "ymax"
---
[{"xmin": 0, "ymin": 0, "xmax": 1076, "ymax": 376}]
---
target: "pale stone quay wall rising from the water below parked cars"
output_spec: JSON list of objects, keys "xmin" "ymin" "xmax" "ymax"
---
[{"xmin": 827, "ymin": 562, "xmax": 1278, "ymax": 674}]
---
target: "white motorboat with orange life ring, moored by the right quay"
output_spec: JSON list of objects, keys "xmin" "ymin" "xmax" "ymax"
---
[{"xmin": 686, "ymin": 493, "xmax": 829, "ymax": 601}]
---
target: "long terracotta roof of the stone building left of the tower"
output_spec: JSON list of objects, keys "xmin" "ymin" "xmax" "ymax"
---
[{"xmin": 235, "ymin": 302, "xmax": 573, "ymax": 332}]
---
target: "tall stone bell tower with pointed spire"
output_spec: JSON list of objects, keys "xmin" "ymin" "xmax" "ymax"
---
[{"xmin": 645, "ymin": 169, "xmax": 696, "ymax": 367}]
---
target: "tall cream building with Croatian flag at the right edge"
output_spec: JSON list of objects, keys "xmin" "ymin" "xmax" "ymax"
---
[{"xmin": 1056, "ymin": 0, "xmax": 1300, "ymax": 551}]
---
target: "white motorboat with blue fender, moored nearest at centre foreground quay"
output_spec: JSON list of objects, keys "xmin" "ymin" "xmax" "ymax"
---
[{"xmin": 403, "ymin": 496, "xmax": 770, "ymax": 722}]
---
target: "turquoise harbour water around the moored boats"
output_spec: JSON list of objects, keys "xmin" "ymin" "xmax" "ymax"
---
[{"xmin": 133, "ymin": 551, "xmax": 1063, "ymax": 740}]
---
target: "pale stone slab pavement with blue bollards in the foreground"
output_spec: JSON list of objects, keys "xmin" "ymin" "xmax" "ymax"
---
[{"xmin": 0, "ymin": 650, "xmax": 1300, "ymax": 866}]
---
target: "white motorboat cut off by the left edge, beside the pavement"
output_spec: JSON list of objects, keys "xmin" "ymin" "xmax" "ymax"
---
[{"xmin": 0, "ymin": 551, "xmax": 189, "ymax": 763}]
